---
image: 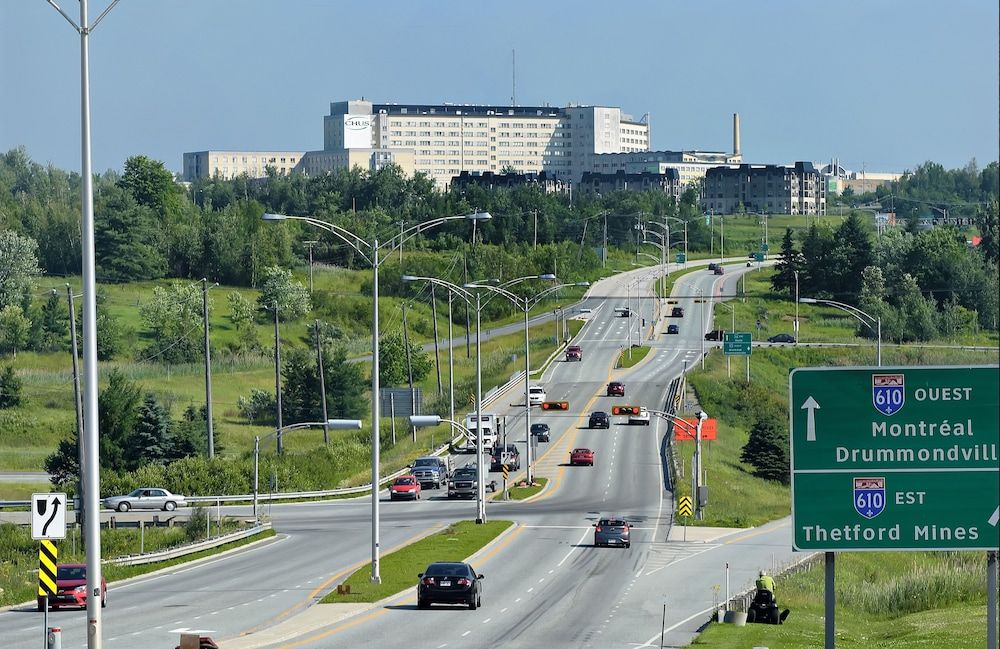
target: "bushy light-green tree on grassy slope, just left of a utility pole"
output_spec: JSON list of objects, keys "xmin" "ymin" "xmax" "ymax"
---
[{"xmin": 139, "ymin": 284, "xmax": 205, "ymax": 363}]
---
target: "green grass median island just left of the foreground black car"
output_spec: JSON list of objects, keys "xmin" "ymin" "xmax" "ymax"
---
[{"xmin": 320, "ymin": 521, "xmax": 513, "ymax": 604}]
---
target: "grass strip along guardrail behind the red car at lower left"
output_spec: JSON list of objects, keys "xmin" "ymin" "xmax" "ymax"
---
[{"xmin": 0, "ymin": 518, "xmax": 274, "ymax": 606}]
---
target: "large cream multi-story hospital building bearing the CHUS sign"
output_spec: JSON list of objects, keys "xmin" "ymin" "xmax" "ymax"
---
[{"xmin": 304, "ymin": 100, "xmax": 649, "ymax": 188}]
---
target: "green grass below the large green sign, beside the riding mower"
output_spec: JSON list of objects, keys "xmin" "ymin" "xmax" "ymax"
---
[{"xmin": 692, "ymin": 552, "xmax": 986, "ymax": 649}]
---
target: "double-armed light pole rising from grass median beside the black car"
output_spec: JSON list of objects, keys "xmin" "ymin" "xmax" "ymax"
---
[{"xmin": 261, "ymin": 212, "xmax": 491, "ymax": 584}]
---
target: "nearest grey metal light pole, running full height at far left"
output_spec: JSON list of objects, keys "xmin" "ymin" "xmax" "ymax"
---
[{"xmin": 48, "ymin": 0, "xmax": 118, "ymax": 649}]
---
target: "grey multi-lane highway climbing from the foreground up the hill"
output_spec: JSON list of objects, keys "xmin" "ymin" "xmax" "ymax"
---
[{"xmin": 0, "ymin": 263, "xmax": 791, "ymax": 649}]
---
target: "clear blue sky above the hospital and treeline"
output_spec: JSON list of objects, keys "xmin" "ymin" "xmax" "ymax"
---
[{"xmin": 0, "ymin": 0, "xmax": 1000, "ymax": 171}]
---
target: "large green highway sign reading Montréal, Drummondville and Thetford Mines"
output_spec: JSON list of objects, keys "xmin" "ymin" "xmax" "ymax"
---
[{"xmin": 788, "ymin": 365, "xmax": 1000, "ymax": 552}]
